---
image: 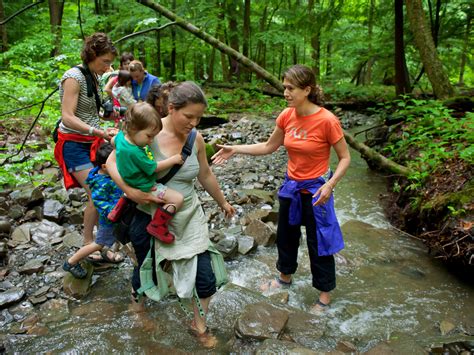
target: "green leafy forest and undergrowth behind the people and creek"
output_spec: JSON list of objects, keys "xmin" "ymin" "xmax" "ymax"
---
[{"xmin": 0, "ymin": 0, "xmax": 474, "ymax": 264}]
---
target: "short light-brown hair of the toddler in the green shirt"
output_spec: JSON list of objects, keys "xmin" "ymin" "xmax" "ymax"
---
[{"xmin": 124, "ymin": 102, "xmax": 163, "ymax": 133}]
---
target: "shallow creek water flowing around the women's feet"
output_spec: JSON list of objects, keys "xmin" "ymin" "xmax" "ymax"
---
[{"xmin": 7, "ymin": 131, "xmax": 474, "ymax": 354}]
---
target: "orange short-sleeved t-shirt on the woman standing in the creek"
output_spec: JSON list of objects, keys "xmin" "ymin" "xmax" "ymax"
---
[{"xmin": 276, "ymin": 107, "xmax": 344, "ymax": 181}]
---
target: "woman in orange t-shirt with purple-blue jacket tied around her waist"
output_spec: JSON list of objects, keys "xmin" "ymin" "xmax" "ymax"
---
[{"xmin": 212, "ymin": 65, "xmax": 350, "ymax": 312}]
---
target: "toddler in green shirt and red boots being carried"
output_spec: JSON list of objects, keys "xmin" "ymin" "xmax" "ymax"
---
[{"xmin": 112, "ymin": 102, "xmax": 183, "ymax": 244}]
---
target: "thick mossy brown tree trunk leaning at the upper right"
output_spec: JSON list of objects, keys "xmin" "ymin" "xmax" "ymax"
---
[{"xmin": 406, "ymin": 0, "xmax": 454, "ymax": 99}]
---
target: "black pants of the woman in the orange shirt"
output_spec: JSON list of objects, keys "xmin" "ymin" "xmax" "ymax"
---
[{"xmin": 276, "ymin": 193, "xmax": 336, "ymax": 292}]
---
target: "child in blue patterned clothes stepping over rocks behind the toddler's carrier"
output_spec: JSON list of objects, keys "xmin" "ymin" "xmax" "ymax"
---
[{"xmin": 63, "ymin": 143, "xmax": 123, "ymax": 279}]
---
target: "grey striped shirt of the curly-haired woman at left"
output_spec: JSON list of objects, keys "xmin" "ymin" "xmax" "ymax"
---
[{"xmin": 59, "ymin": 68, "xmax": 100, "ymax": 136}]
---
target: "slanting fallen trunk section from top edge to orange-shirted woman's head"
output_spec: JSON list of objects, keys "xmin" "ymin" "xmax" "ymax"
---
[{"xmin": 137, "ymin": 0, "xmax": 283, "ymax": 91}]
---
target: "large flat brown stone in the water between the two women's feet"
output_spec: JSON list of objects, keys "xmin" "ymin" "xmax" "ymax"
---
[{"xmin": 234, "ymin": 302, "xmax": 289, "ymax": 340}]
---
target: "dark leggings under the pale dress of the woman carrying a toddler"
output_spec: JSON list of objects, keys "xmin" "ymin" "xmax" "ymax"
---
[{"xmin": 129, "ymin": 210, "xmax": 216, "ymax": 298}]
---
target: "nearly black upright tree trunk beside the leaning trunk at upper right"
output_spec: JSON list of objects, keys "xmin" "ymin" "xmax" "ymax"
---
[{"xmin": 394, "ymin": 0, "xmax": 411, "ymax": 96}]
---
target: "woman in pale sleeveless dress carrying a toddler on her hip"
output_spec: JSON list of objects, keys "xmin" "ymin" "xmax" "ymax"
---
[{"xmin": 107, "ymin": 82, "xmax": 235, "ymax": 347}]
